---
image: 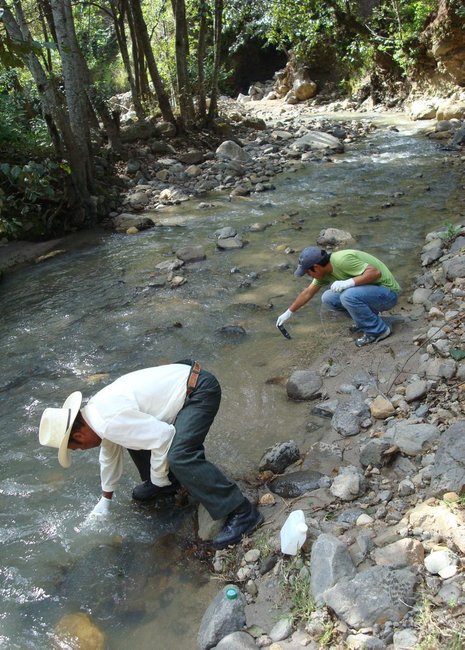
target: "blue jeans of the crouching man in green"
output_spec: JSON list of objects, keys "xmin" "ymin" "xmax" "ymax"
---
[{"xmin": 321, "ymin": 284, "xmax": 397, "ymax": 336}]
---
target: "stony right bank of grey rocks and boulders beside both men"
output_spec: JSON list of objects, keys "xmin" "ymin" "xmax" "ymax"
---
[{"xmin": 198, "ymin": 220, "xmax": 465, "ymax": 650}]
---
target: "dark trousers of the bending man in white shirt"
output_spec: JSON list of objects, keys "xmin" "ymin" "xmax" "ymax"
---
[{"xmin": 128, "ymin": 370, "xmax": 244, "ymax": 519}]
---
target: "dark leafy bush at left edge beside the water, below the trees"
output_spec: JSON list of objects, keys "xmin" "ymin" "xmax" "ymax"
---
[{"xmin": 0, "ymin": 159, "xmax": 70, "ymax": 239}]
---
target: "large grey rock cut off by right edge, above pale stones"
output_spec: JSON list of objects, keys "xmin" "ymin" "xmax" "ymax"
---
[{"xmin": 430, "ymin": 420, "xmax": 465, "ymax": 496}]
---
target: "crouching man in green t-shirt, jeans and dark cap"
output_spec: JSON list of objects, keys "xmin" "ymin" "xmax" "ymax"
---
[{"xmin": 276, "ymin": 246, "xmax": 400, "ymax": 347}]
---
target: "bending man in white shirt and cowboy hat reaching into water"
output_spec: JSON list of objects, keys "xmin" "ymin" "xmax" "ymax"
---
[{"xmin": 39, "ymin": 361, "xmax": 263, "ymax": 549}]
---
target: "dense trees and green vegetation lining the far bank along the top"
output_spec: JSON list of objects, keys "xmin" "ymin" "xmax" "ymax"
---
[{"xmin": 0, "ymin": 0, "xmax": 461, "ymax": 239}]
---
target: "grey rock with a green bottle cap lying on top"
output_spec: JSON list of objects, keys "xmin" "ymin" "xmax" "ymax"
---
[{"xmin": 197, "ymin": 585, "xmax": 246, "ymax": 650}]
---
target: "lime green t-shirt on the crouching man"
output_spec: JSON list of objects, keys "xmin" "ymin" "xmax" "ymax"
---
[{"xmin": 312, "ymin": 249, "xmax": 400, "ymax": 293}]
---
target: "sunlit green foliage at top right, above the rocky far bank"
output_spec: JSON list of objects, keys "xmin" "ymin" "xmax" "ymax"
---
[{"xmin": 262, "ymin": 0, "xmax": 438, "ymax": 74}]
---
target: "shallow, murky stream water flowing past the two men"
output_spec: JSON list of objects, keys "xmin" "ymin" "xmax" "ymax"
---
[{"xmin": 0, "ymin": 116, "xmax": 456, "ymax": 650}]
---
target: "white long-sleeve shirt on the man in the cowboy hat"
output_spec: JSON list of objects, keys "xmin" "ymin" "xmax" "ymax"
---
[{"xmin": 81, "ymin": 363, "xmax": 190, "ymax": 492}]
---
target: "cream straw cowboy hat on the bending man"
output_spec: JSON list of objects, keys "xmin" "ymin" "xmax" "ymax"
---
[{"xmin": 39, "ymin": 391, "xmax": 82, "ymax": 467}]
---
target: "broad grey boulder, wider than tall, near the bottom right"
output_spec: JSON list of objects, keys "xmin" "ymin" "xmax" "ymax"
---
[{"xmin": 323, "ymin": 567, "xmax": 416, "ymax": 630}]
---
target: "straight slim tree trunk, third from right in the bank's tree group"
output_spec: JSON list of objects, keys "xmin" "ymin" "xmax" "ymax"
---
[{"xmin": 171, "ymin": 0, "xmax": 194, "ymax": 127}]
